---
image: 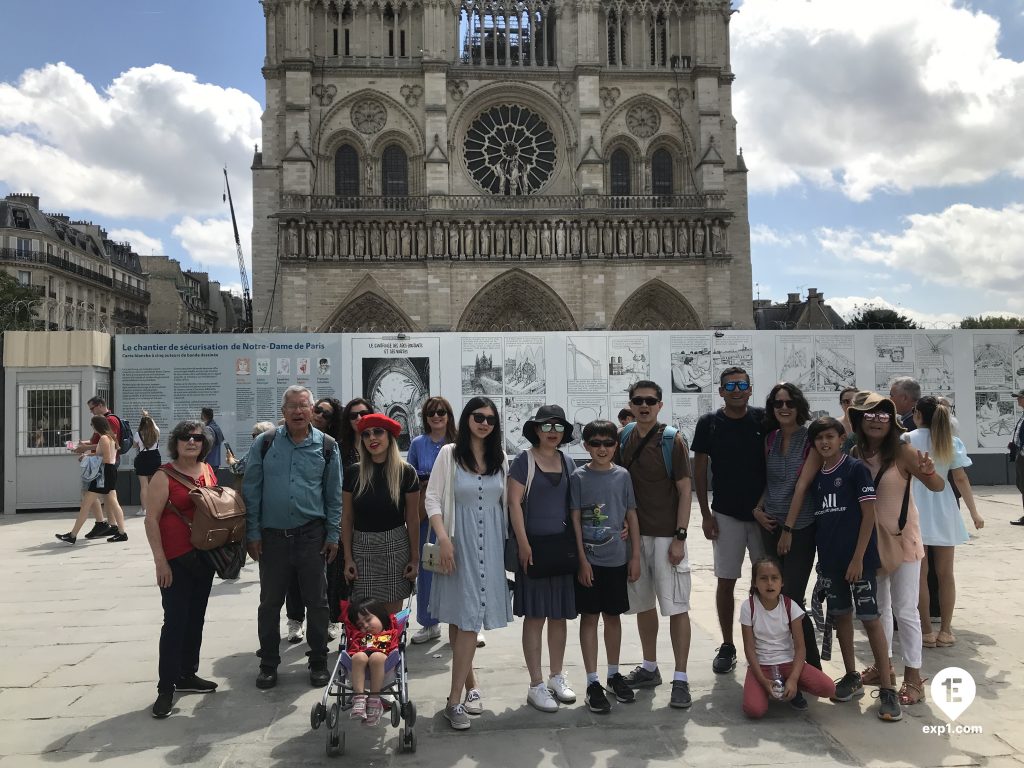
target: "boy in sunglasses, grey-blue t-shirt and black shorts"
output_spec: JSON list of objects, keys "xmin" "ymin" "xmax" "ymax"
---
[{"xmin": 569, "ymin": 420, "xmax": 640, "ymax": 714}]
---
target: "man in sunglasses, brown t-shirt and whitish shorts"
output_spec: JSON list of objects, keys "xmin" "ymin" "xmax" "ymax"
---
[{"xmin": 617, "ymin": 381, "xmax": 692, "ymax": 709}]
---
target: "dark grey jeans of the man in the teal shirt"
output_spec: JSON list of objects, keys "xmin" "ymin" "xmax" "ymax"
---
[{"xmin": 257, "ymin": 520, "xmax": 328, "ymax": 668}]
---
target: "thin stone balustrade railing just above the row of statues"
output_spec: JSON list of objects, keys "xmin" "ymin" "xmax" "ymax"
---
[{"xmin": 282, "ymin": 193, "xmax": 725, "ymax": 215}]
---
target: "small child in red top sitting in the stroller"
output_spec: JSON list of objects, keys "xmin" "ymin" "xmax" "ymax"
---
[{"xmin": 347, "ymin": 598, "xmax": 401, "ymax": 725}]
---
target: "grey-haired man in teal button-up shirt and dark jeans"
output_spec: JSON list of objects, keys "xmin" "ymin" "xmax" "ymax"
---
[{"xmin": 242, "ymin": 386, "xmax": 341, "ymax": 688}]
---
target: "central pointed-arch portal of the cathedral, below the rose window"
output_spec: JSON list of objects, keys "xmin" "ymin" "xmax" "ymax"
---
[{"xmin": 457, "ymin": 269, "xmax": 577, "ymax": 332}]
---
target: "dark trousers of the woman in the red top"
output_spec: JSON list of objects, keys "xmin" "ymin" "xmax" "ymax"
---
[{"xmin": 157, "ymin": 550, "xmax": 213, "ymax": 693}]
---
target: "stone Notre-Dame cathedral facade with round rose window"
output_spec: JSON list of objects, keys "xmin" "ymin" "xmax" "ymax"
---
[{"xmin": 252, "ymin": 0, "xmax": 753, "ymax": 332}]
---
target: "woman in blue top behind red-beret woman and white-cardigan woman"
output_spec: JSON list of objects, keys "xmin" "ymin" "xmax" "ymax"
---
[{"xmin": 407, "ymin": 395, "xmax": 458, "ymax": 643}]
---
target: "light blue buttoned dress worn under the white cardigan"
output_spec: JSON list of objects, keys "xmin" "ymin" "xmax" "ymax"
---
[{"xmin": 429, "ymin": 467, "xmax": 512, "ymax": 632}]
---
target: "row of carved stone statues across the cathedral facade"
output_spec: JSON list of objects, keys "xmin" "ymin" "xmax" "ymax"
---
[{"xmin": 279, "ymin": 212, "xmax": 731, "ymax": 261}]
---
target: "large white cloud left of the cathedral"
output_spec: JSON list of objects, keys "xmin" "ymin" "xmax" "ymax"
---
[{"xmin": 0, "ymin": 62, "xmax": 260, "ymax": 222}]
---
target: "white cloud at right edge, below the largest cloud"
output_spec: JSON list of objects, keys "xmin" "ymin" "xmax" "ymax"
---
[{"xmin": 817, "ymin": 204, "xmax": 1024, "ymax": 307}]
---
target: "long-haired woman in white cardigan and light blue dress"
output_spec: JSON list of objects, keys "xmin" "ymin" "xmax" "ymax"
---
[{"xmin": 425, "ymin": 397, "xmax": 512, "ymax": 730}]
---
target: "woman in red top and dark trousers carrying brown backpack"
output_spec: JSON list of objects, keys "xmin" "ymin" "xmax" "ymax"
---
[{"xmin": 145, "ymin": 421, "xmax": 217, "ymax": 719}]
